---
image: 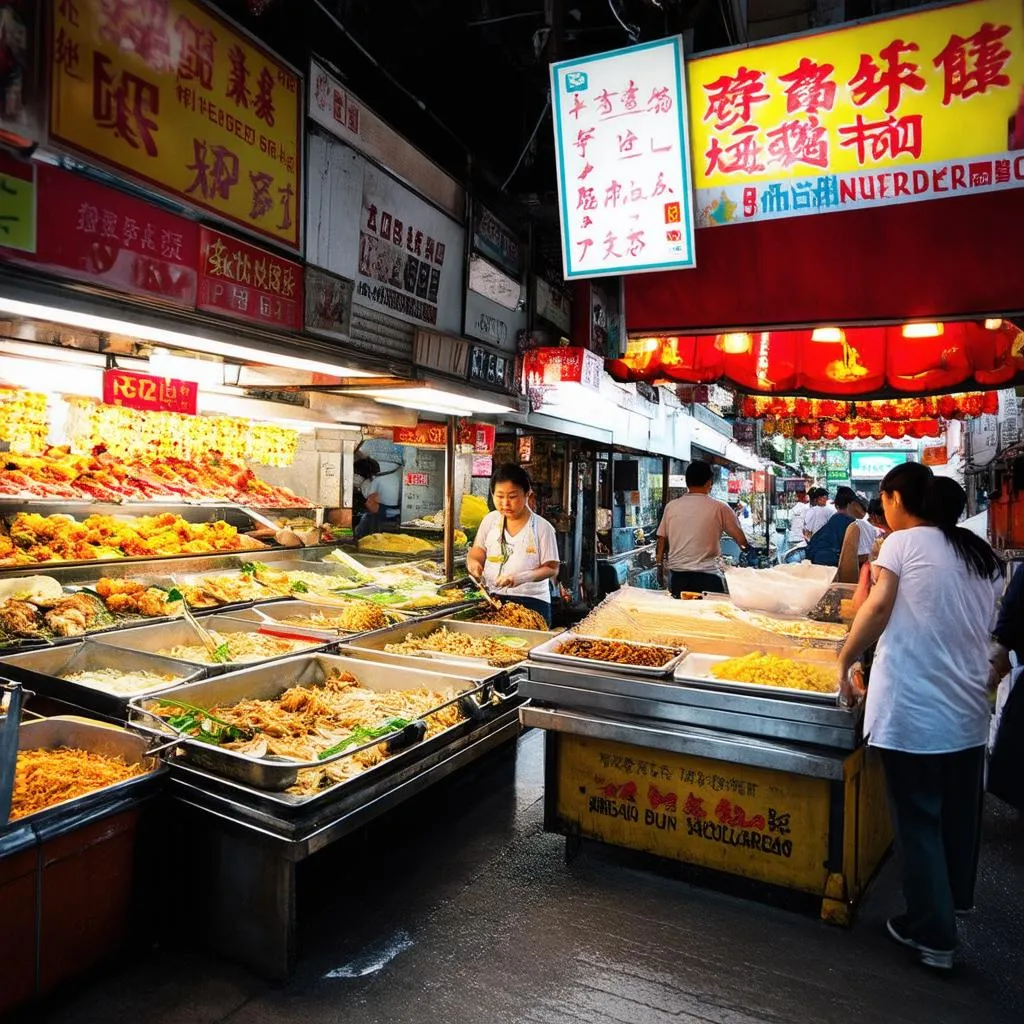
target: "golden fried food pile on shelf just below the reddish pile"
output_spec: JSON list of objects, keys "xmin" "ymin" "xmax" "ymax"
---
[{"xmin": 0, "ymin": 512, "xmax": 263, "ymax": 565}]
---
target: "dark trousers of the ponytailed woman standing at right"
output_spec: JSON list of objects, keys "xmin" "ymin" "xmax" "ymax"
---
[{"xmin": 882, "ymin": 746, "xmax": 985, "ymax": 949}]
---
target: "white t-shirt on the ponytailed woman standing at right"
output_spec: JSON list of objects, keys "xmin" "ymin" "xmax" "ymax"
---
[{"xmin": 864, "ymin": 526, "xmax": 1002, "ymax": 754}]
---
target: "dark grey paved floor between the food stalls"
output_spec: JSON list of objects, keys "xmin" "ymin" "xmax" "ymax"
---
[{"xmin": 28, "ymin": 732, "xmax": 1024, "ymax": 1024}]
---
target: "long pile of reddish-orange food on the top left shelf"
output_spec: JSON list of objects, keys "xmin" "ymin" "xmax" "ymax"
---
[{"xmin": 0, "ymin": 446, "xmax": 312, "ymax": 508}]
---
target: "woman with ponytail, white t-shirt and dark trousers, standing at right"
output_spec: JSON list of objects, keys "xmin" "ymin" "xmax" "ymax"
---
[{"xmin": 839, "ymin": 463, "xmax": 1002, "ymax": 970}]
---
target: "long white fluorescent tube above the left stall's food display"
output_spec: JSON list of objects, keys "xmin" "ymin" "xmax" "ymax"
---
[{"xmin": 0, "ymin": 296, "xmax": 373, "ymax": 377}]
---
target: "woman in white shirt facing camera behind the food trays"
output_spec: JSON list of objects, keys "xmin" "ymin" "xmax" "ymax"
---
[{"xmin": 466, "ymin": 463, "xmax": 559, "ymax": 626}]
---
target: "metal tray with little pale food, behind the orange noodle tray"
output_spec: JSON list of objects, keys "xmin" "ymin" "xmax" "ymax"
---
[{"xmin": 0, "ymin": 640, "xmax": 206, "ymax": 722}]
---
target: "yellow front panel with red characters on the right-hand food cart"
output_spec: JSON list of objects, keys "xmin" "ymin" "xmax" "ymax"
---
[{"xmin": 556, "ymin": 734, "xmax": 829, "ymax": 894}]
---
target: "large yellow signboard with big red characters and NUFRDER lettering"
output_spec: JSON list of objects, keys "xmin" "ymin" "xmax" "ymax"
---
[{"xmin": 687, "ymin": 0, "xmax": 1024, "ymax": 227}]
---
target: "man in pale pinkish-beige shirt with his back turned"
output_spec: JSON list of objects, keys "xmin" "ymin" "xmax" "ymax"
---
[{"xmin": 656, "ymin": 462, "xmax": 748, "ymax": 597}]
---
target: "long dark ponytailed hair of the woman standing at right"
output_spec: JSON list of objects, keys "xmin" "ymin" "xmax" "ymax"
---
[{"xmin": 879, "ymin": 462, "xmax": 1002, "ymax": 580}]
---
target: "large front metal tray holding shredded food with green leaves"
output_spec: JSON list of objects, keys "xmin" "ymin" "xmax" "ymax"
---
[{"xmin": 129, "ymin": 654, "xmax": 486, "ymax": 791}]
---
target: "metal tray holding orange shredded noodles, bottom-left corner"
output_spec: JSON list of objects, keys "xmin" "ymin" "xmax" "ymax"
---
[{"xmin": 0, "ymin": 716, "xmax": 167, "ymax": 834}]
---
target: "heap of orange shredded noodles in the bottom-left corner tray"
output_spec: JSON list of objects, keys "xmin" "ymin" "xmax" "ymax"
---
[{"xmin": 10, "ymin": 746, "xmax": 146, "ymax": 821}]
